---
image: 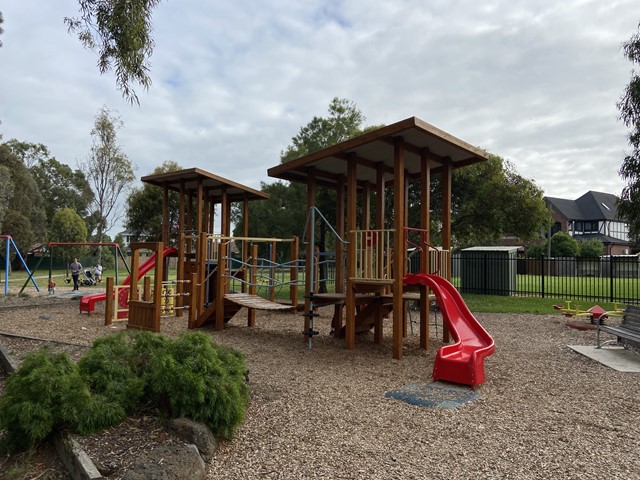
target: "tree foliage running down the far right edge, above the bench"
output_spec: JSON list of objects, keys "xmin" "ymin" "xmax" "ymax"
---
[{"xmin": 618, "ymin": 24, "xmax": 640, "ymax": 243}]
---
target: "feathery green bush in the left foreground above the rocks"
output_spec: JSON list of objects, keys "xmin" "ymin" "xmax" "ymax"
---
[{"xmin": 0, "ymin": 332, "xmax": 249, "ymax": 451}]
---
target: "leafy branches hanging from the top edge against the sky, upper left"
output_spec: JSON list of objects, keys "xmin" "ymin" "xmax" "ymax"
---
[{"xmin": 64, "ymin": 0, "xmax": 160, "ymax": 104}]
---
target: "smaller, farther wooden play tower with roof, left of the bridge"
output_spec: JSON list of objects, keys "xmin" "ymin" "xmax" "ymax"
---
[{"xmin": 142, "ymin": 168, "xmax": 280, "ymax": 330}]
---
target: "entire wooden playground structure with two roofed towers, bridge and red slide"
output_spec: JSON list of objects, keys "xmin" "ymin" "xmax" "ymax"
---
[{"xmin": 102, "ymin": 117, "xmax": 494, "ymax": 385}]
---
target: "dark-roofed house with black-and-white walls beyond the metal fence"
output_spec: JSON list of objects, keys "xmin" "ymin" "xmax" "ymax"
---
[{"xmin": 544, "ymin": 190, "xmax": 631, "ymax": 255}]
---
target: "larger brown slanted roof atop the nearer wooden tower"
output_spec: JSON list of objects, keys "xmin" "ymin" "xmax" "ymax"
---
[{"xmin": 268, "ymin": 117, "xmax": 488, "ymax": 187}]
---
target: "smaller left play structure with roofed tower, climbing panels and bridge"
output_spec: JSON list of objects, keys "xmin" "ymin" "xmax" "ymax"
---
[{"xmin": 95, "ymin": 168, "xmax": 301, "ymax": 331}]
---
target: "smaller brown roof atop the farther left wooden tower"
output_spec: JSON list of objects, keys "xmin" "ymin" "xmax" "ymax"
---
[{"xmin": 141, "ymin": 168, "xmax": 269, "ymax": 203}]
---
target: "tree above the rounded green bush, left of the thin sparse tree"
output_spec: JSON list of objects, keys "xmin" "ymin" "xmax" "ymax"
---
[{"xmin": 31, "ymin": 157, "xmax": 93, "ymax": 225}]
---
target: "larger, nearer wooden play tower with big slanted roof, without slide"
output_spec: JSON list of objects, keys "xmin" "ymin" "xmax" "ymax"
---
[{"xmin": 268, "ymin": 117, "xmax": 487, "ymax": 359}]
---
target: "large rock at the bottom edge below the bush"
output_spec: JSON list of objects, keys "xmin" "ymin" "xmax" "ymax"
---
[{"xmin": 122, "ymin": 445, "xmax": 207, "ymax": 480}]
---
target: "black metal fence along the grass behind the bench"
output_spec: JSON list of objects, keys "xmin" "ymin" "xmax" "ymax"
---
[{"xmin": 452, "ymin": 252, "xmax": 640, "ymax": 304}]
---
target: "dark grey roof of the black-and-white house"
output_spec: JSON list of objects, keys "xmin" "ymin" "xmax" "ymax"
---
[{"xmin": 544, "ymin": 190, "xmax": 618, "ymax": 220}]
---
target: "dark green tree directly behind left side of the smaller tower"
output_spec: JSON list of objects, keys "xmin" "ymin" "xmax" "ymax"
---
[{"xmin": 125, "ymin": 160, "xmax": 182, "ymax": 241}]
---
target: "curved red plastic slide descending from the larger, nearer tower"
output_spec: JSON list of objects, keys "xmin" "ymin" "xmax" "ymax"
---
[{"xmin": 404, "ymin": 273, "xmax": 495, "ymax": 386}]
